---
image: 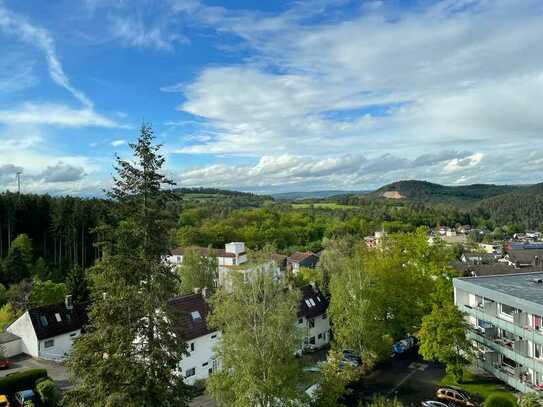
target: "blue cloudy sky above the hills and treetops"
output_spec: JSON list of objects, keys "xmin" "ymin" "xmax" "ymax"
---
[{"xmin": 0, "ymin": 0, "xmax": 543, "ymax": 195}]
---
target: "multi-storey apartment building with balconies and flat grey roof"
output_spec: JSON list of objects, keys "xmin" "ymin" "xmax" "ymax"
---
[{"xmin": 454, "ymin": 273, "xmax": 543, "ymax": 392}]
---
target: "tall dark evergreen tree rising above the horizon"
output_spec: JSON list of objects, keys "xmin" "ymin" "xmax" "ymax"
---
[{"xmin": 67, "ymin": 125, "xmax": 187, "ymax": 406}]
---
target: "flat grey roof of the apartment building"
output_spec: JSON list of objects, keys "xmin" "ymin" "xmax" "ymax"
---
[{"xmin": 455, "ymin": 272, "xmax": 543, "ymax": 305}]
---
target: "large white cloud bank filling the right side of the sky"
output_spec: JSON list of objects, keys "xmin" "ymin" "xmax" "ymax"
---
[{"xmin": 164, "ymin": 0, "xmax": 543, "ymax": 188}]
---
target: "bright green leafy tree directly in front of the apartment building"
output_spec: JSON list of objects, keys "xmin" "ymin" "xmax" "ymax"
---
[{"xmin": 417, "ymin": 302, "xmax": 473, "ymax": 383}]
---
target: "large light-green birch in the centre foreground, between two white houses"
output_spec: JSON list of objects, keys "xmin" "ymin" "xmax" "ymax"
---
[{"xmin": 207, "ymin": 265, "xmax": 303, "ymax": 407}]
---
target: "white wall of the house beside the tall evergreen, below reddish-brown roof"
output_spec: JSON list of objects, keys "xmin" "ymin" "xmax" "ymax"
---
[{"xmin": 179, "ymin": 332, "xmax": 221, "ymax": 385}]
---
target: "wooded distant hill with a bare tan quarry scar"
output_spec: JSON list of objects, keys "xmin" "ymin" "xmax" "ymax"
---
[{"xmin": 370, "ymin": 180, "xmax": 528, "ymax": 202}]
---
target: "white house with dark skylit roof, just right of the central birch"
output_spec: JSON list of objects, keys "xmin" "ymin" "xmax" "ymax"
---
[{"xmin": 298, "ymin": 284, "xmax": 330, "ymax": 350}]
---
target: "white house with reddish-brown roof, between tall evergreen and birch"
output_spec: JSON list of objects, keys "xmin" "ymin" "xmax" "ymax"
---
[{"xmin": 170, "ymin": 293, "xmax": 220, "ymax": 385}]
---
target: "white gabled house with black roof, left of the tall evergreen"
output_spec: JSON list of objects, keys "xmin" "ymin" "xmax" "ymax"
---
[{"xmin": 6, "ymin": 299, "xmax": 86, "ymax": 361}]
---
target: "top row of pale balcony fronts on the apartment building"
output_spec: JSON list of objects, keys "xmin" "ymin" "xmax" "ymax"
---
[{"xmin": 458, "ymin": 303, "xmax": 543, "ymax": 345}]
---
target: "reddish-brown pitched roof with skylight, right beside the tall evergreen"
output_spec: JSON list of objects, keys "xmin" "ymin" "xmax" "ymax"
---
[{"xmin": 169, "ymin": 294, "xmax": 215, "ymax": 340}]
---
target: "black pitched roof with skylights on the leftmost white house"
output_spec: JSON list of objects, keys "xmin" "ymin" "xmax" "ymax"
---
[{"xmin": 28, "ymin": 302, "xmax": 87, "ymax": 340}]
